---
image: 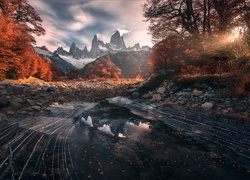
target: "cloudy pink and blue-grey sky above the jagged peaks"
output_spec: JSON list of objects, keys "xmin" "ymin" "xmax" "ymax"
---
[{"xmin": 29, "ymin": 0, "xmax": 152, "ymax": 51}]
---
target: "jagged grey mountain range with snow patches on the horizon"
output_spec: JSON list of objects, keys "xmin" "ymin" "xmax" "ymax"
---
[{"xmin": 35, "ymin": 31, "xmax": 150, "ymax": 78}]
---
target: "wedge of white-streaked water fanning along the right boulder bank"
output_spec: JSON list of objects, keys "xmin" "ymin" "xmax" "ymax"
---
[{"xmin": 109, "ymin": 97, "xmax": 250, "ymax": 169}]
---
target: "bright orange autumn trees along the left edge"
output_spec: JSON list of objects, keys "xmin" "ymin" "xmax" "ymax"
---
[{"xmin": 0, "ymin": 0, "xmax": 53, "ymax": 81}]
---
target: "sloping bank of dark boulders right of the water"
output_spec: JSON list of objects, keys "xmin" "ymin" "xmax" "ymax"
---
[{"xmin": 137, "ymin": 74, "xmax": 250, "ymax": 120}]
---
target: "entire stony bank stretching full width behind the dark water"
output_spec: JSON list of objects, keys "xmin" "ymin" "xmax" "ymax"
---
[{"xmin": 0, "ymin": 76, "xmax": 250, "ymax": 120}]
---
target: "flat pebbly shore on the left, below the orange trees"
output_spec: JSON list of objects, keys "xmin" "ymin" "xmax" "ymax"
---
[{"xmin": 0, "ymin": 80, "xmax": 135, "ymax": 120}]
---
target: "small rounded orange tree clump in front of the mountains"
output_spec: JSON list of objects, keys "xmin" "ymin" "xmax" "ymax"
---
[{"xmin": 85, "ymin": 58, "xmax": 121, "ymax": 79}]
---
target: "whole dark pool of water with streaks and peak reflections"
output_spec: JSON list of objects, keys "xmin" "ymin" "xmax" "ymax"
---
[{"xmin": 0, "ymin": 97, "xmax": 250, "ymax": 179}]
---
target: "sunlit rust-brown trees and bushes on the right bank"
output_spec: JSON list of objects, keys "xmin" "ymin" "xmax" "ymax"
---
[{"xmin": 143, "ymin": 0, "xmax": 250, "ymax": 94}]
